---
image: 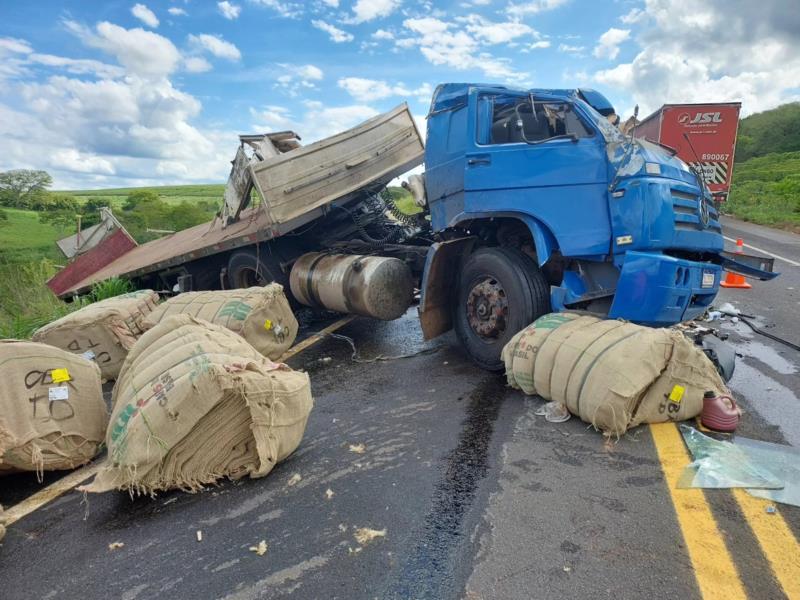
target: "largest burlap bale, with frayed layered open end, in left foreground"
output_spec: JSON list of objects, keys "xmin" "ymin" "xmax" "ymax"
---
[{"xmin": 82, "ymin": 315, "xmax": 313, "ymax": 494}]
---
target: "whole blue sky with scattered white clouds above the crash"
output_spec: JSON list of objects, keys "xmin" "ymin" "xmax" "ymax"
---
[{"xmin": 0, "ymin": 0, "xmax": 800, "ymax": 188}]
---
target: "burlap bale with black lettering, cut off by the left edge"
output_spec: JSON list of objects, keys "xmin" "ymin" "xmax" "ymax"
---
[{"xmin": 0, "ymin": 340, "xmax": 108, "ymax": 473}]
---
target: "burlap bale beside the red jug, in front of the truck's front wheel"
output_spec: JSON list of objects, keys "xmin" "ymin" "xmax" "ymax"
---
[{"xmin": 504, "ymin": 315, "xmax": 729, "ymax": 435}]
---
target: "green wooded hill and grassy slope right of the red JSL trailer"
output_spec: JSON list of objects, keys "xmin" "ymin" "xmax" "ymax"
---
[{"xmin": 725, "ymin": 102, "xmax": 800, "ymax": 229}]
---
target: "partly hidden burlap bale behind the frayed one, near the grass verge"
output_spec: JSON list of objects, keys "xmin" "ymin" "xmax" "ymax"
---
[{"xmin": 33, "ymin": 290, "xmax": 158, "ymax": 379}]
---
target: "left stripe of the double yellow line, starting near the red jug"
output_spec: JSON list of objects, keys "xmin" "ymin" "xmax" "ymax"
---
[{"xmin": 650, "ymin": 423, "xmax": 747, "ymax": 600}]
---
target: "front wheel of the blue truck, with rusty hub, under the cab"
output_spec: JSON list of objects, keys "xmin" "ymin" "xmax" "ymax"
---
[{"xmin": 453, "ymin": 248, "xmax": 550, "ymax": 371}]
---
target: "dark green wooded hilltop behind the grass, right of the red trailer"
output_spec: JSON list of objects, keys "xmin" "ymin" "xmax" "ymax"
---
[{"xmin": 736, "ymin": 102, "xmax": 800, "ymax": 163}]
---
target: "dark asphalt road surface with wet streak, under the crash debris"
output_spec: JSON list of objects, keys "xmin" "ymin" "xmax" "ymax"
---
[{"xmin": 0, "ymin": 217, "xmax": 800, "ymax": 600}]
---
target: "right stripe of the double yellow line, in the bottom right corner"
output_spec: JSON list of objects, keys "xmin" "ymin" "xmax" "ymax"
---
[{"xmin": 733, "ymin": 489, "xmax": 800, "ymax": 598}]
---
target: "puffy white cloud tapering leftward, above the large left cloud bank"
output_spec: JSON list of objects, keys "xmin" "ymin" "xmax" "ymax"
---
[{"xmin": 64, "ymin": 21, "xmax": 181, "ymax": 77}]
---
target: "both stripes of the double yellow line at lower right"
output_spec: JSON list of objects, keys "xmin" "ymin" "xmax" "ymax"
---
[{"xmin": 650, "ymin": 423, "xmax": 800, "ymax": 600}]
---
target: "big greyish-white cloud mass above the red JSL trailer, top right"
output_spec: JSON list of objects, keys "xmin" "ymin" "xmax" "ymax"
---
[{"xmin": 594, "ymin": 0, "xmax": 800, "ymax": 114}]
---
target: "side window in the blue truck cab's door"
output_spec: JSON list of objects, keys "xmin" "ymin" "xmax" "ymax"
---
[{"xmin": 480, "ymin": 96, "xmax": 592, "ymax": 144}]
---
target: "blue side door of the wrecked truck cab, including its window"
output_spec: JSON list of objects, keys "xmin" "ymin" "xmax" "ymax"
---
[{"xmin": 464, "ymin": 90, "xmax": 611, "ymax": 257}]
